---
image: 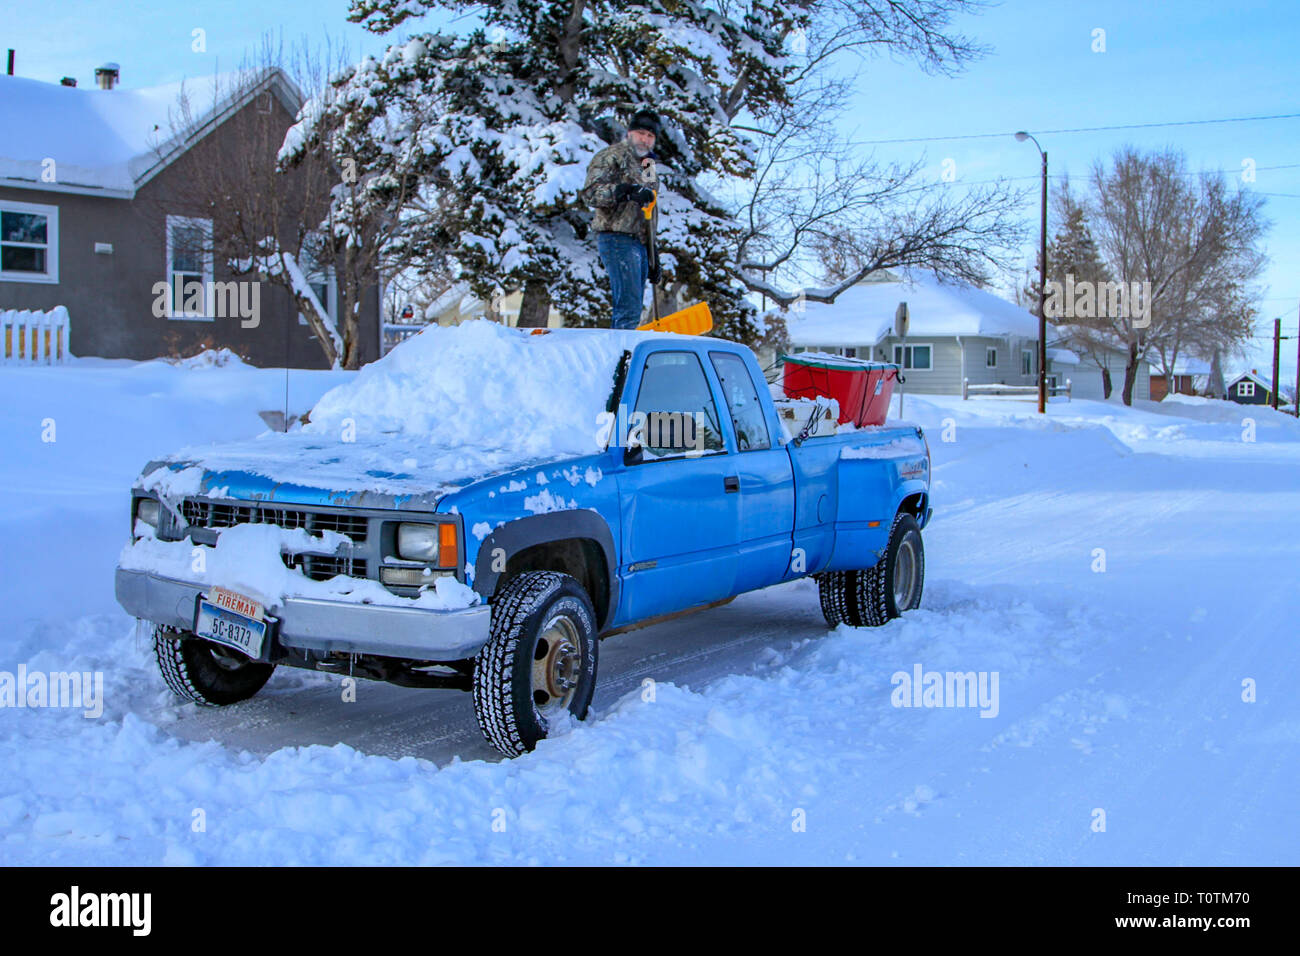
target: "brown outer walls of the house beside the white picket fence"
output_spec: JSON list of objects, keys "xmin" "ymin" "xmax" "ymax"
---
[{"xmin": 0, "ymin": 89, "xmax": 380, "ymax": 368}]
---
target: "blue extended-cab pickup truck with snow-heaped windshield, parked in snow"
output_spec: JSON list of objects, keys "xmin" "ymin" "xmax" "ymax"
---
[{"xmin": 116, "ymin": 324, "xmax": 930, "ymax": 754}]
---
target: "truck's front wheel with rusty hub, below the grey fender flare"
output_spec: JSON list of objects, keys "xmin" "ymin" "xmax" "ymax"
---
[{"xmin": 475, "ymin": 571, "xmax": 598, "ymax": 757}]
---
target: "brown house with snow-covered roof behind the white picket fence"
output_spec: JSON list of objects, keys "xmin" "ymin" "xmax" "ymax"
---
[{"xmin": 0, "ymin": 64, "xmax": 380, "ymax": 367}]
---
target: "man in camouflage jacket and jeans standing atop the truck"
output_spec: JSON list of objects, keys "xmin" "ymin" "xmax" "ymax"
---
[{"xmin": 581, "ymin": 109, "xmax": 659, "ymax": 329}]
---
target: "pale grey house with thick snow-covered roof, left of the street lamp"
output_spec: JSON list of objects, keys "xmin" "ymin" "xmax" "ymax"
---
[{"xmin": 785, "ymin": 273, "xmax": 1065, "ymax": 395}]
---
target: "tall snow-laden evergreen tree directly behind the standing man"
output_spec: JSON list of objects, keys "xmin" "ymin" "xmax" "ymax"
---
[{"xmin": 286, "ymin": 0, "xmax": 807, "ymax": 339}]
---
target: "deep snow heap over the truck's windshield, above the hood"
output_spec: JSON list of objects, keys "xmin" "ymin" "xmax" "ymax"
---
[{"xmin": 304, "ymin": 320, "xmax": 646, "ymax": 460}]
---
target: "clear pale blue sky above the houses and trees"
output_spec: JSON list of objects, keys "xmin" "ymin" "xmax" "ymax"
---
[{"xmin": 10, "ymin": 0, "xmax": 1300, "ymax": 381}]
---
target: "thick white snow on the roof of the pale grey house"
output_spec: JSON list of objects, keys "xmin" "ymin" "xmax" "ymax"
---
[{"xmin": 787, "ymin": 273, "xmax": 1039, "ymax": 346}]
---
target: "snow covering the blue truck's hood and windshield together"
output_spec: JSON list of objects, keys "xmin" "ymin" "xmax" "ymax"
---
[{"xmin": 140, "ymin": 320, "xmax": 662, "ymax": 499}]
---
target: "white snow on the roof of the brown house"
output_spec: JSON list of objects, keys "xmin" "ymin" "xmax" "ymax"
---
[{"xmin": 0, "ymin": 73, "xmax": 296, "ymax": 198}]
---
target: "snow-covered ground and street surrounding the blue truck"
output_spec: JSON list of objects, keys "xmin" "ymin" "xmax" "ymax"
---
[{"xmin": 0, "ymin": 362, "xmax": 1300, "ymax": 865}]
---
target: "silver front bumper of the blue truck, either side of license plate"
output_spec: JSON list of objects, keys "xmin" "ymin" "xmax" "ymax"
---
[{"xmin": 116, "ymin": 568, "xmax": 491, "ymax": 661}]
